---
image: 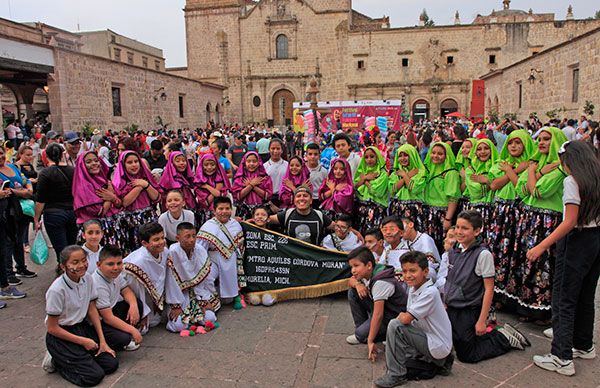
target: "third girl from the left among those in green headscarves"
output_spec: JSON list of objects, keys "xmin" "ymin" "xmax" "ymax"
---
[{"xmin": 423, "ymin": 142, "xmax": 461, "ymax": 250}]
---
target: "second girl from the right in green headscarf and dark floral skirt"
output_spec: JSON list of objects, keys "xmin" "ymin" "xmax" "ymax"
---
[{"xmin": 486, "ymin": 129, "xmax": 535, "ymax": 299}]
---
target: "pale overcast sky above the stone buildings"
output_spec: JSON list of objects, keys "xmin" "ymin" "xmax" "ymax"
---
[{"xmin": 0, "ymin": 0, "xmax": 600, "ymax": 67}]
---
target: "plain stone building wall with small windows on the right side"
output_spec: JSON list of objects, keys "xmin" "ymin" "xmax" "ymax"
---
[{"xmin": 481, "ymin": 28, "xmax": 600, "ymax": 120}]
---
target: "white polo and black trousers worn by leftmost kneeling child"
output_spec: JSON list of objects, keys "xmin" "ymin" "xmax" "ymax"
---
[{"xmin": 46, "ymin": 274, "xmax": 119, "ymax": 386}]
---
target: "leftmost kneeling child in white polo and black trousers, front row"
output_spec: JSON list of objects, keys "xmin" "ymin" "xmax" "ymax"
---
[{"xmin": 42, "ymin": 245, "xmax": 119, "ymax": 387}]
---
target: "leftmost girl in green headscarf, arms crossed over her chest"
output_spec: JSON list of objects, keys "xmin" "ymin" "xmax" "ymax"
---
[{"xmin": 354, "ymin": 147, "xmax": 389, "ymax": 235}]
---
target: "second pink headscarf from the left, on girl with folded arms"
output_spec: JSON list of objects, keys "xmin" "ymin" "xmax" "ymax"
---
[{"xmin": 112, "ymin": 151, "xmax": 159, "ymax": 211}]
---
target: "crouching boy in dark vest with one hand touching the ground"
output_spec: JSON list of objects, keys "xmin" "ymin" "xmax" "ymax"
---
[{"xmin": 346, "ymin": 247, "xmax": 407, "ymax": 360}]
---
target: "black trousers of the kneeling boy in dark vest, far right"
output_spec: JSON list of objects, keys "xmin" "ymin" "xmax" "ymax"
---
[{"xmin": 446, "ymin": 306, "xmax": 511, "ymax": 363}]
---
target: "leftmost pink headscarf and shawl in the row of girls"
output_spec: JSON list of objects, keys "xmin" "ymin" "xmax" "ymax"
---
[{"xmin": 72, "ymin": 151, "xmax": 114, "ymax": 214}]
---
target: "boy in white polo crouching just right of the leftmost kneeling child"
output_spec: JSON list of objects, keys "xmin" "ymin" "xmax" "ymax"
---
[{"xmin": 92, "ymin": 245, "xmax": 143, "ymax": 351}]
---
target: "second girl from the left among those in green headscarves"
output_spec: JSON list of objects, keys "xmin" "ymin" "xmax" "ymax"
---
[{"xmin": 389, "ymin": 144, "xmax": 427, "ymax": 230}]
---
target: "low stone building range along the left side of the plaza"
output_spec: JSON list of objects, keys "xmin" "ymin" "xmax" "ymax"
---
[{"xmin": 0, "ymin": 19, "xmax": 223, "ymax": 131}]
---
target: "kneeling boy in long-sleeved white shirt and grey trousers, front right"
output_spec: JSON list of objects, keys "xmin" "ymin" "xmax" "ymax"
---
[{"xmin": 375, "ymin": 251, "xmax": 454, "ymax": 387}]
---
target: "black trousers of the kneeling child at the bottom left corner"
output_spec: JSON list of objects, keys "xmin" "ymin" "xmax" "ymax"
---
[{"xmin": 46, "ymin": 321, "xmax": 119, "ymax": 387}]
